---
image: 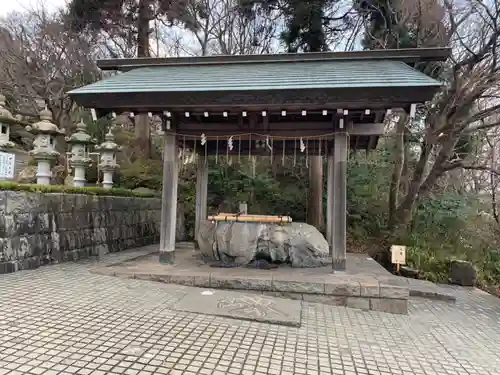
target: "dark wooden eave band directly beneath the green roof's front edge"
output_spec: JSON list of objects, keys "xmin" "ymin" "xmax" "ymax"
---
[{"xmin": 70, "ymin": 86, "xmax": 440, "ymax": 113}]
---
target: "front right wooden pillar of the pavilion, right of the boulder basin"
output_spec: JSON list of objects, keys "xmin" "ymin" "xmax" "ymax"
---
[{"xmin": 332, "ymin": 133, "xmax": 347, "ymax": 271}]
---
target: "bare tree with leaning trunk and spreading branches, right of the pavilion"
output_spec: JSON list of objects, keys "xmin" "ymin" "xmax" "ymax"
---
[{"xmin": 389, "ymin": 0, "xmax": 500, "ymax": 226}]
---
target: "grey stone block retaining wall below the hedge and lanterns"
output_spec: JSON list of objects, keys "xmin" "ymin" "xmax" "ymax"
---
[{"xmin": 0, "ymin": 191, "xmax": 161, "ymax": 273}]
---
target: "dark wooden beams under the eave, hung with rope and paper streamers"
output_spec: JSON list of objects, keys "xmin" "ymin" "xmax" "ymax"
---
[{"xmin": 169, "ymin": 110, "xmax": 384, "ymax": 155}]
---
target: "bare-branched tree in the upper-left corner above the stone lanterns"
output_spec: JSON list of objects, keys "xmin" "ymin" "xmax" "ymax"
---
[{"xmin": 0, "ymin": 7, "xmax": 99, "ymax": 128}]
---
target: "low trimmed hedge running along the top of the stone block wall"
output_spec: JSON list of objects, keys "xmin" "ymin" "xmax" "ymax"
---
[{"xmin": 0, "ymin": 182, "xmax": 156, "ymax": 198}]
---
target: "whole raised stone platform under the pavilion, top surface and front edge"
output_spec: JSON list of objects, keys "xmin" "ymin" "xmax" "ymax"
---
[{"xmin": 92, "ymin": 245, "xmax": 448, "ymax": 314}]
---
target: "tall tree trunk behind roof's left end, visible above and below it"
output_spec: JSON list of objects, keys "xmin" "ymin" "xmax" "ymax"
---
[{"xmin": 134, "ymin": 0, "xmax": 151, "ymax": 159}]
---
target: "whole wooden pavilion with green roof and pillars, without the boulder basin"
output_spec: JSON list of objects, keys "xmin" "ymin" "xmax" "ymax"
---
[{"xmin": 69, "ymin": 48, "xmax": 450, "ymax": 270}]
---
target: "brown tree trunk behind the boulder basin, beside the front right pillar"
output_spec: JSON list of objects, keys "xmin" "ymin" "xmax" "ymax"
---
[{"xmin": 307, "ymin": 156, "xmax": 324, "ymax": 230}]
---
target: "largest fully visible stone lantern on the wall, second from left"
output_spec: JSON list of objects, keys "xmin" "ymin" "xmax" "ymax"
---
[{"xmin": 26, "ymin": 109, "xmax": 64, "ymax": 185}]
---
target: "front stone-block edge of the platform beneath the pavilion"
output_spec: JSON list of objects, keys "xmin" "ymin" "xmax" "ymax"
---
[{"xmin": 93, "ymin": 267, "xmax": 409, "ymax": 314}]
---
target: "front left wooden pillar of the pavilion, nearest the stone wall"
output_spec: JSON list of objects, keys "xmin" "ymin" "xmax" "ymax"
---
[{"xmin": 160, "ymin": 130, "xmax": 179, "ymax": 264}]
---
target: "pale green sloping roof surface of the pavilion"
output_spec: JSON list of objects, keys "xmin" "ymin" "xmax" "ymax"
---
[{"xmin": 69, "ymin": 59, "xmax": 441, "ymax": 96}]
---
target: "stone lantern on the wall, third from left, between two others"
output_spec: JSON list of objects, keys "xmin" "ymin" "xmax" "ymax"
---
[{"xmin": 66, "ymin": 120, "xmax": 95, "ymax": 187}]
